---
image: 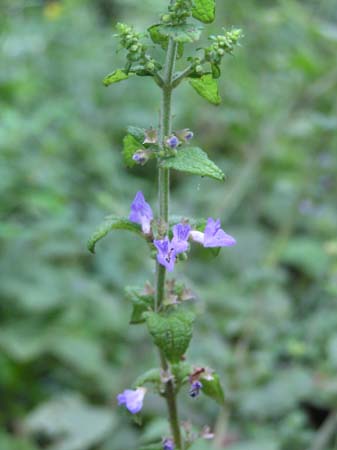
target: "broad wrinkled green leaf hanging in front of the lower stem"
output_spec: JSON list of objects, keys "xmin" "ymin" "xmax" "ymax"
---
[{"xmin": 145, "ymin": 310, "xmax": 194, "ymax": 363}]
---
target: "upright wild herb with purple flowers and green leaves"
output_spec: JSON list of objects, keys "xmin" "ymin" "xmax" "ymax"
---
[{"xmin": 88, "ymin": 0, "xmax": 241, "ymax": 450}]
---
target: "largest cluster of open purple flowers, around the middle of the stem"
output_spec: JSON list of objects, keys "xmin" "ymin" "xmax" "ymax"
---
[{"xmin": 129, "ymin": 192, "xmax": 236, "ymax": 272}]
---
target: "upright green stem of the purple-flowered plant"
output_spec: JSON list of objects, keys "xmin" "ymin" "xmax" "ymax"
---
[{"xmin": 155, "ymin": 39, "xmax": 182, "ymax": 450}]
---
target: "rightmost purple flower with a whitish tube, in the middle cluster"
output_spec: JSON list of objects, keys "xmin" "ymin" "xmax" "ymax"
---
[{"xmin": 190, "ymin": 217, "xmax": 236, "ymax": 247}]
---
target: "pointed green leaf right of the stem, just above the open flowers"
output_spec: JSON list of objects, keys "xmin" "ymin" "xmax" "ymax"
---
[{"xmin": 161, "ymin": 147, "xmax": 225, "ymax": 181}]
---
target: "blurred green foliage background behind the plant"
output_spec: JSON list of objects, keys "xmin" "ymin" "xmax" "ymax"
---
[{"xmin": 0, "ymin": 0, "xmax": 337, "ymax": 450}]
